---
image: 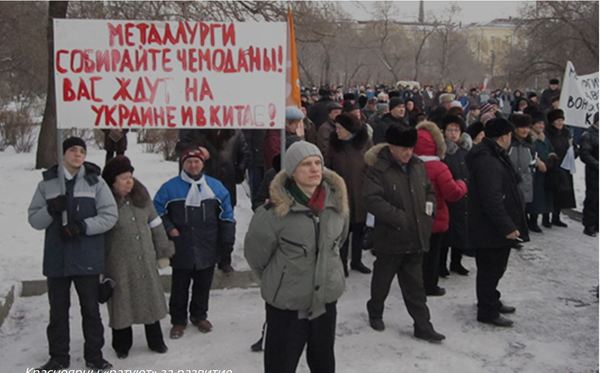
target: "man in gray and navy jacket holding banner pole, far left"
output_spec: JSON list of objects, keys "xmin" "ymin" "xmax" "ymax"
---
[{"xmin": 28, "ymin": 137, "xmax": 118, "ymax": 372}]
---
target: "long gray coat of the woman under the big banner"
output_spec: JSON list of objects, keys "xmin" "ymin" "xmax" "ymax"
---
[{"xmin": 104, "ymin": 180, "xmax": 175, "ymax": 329}]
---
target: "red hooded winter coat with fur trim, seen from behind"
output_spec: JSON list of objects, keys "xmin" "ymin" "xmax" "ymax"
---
[{"xmin": 414, "ymin": 122, "xmax": 467, "ymax": 233}]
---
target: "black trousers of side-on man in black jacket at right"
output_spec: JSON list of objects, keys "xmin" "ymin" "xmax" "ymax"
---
[{"xmin": 475, "ymin": 246, "xmax": 510, "ymax": 320}]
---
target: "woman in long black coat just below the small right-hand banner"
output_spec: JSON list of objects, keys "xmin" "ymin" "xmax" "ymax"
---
[{"xmin": 544, "ymin": 109, "xmax": 577, "ymax": 227}]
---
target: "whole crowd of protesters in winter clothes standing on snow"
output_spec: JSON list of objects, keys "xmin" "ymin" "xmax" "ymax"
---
[{"xmin": 29, "ymin": 79, "xmax": 598, "ymax": 373}]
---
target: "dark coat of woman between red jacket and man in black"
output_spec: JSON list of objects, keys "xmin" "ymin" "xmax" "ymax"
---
[{"xmin": 444, "ymin": 133, "xmax": 473, "ymax": 248}]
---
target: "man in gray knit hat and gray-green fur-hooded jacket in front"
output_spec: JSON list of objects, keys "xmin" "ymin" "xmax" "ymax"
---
[{"xmin": 244, "ymin": 141, "xmax": 349, "ymax": 373}]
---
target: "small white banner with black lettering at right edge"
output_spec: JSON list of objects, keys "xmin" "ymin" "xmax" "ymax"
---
[{"xmin": 560, "ymin": 61, "xmax": 598, "ymax": 127}]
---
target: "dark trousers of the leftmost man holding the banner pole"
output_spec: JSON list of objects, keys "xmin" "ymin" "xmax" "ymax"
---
[{"xmin": 46, "ymin": 275, "xmax": 104, "ymax": 365}]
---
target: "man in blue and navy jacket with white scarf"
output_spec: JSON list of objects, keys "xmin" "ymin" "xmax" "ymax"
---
[{"xmin": 154, "ymin": 147, "xmax": 235, "ymax": 339}]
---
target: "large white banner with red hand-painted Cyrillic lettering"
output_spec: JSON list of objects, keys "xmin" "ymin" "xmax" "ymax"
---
[{"xmin": 54, "ymin": 19, "xmax": 287, "ymax": 129}]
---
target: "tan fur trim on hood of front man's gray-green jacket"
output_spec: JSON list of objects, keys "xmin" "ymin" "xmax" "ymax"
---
[{"xmin": 269, "ymin": 168, "xmax": 350, "ymax": 217}]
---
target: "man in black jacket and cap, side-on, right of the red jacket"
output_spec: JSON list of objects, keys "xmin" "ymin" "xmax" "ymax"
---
[{"xmin": 467, "ymin": 118, "xmax": 528, "ymax": 327}]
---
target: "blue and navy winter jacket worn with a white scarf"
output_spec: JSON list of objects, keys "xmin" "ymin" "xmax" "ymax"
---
[{"xmin": 154, "ymin": 176, "xmax": 235, "ymax": 270}]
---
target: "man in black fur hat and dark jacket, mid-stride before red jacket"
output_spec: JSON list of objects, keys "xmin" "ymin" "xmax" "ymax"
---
[{"xmin": 363, "ymin": 124, "xmax": 445, "ymax": 342}]
